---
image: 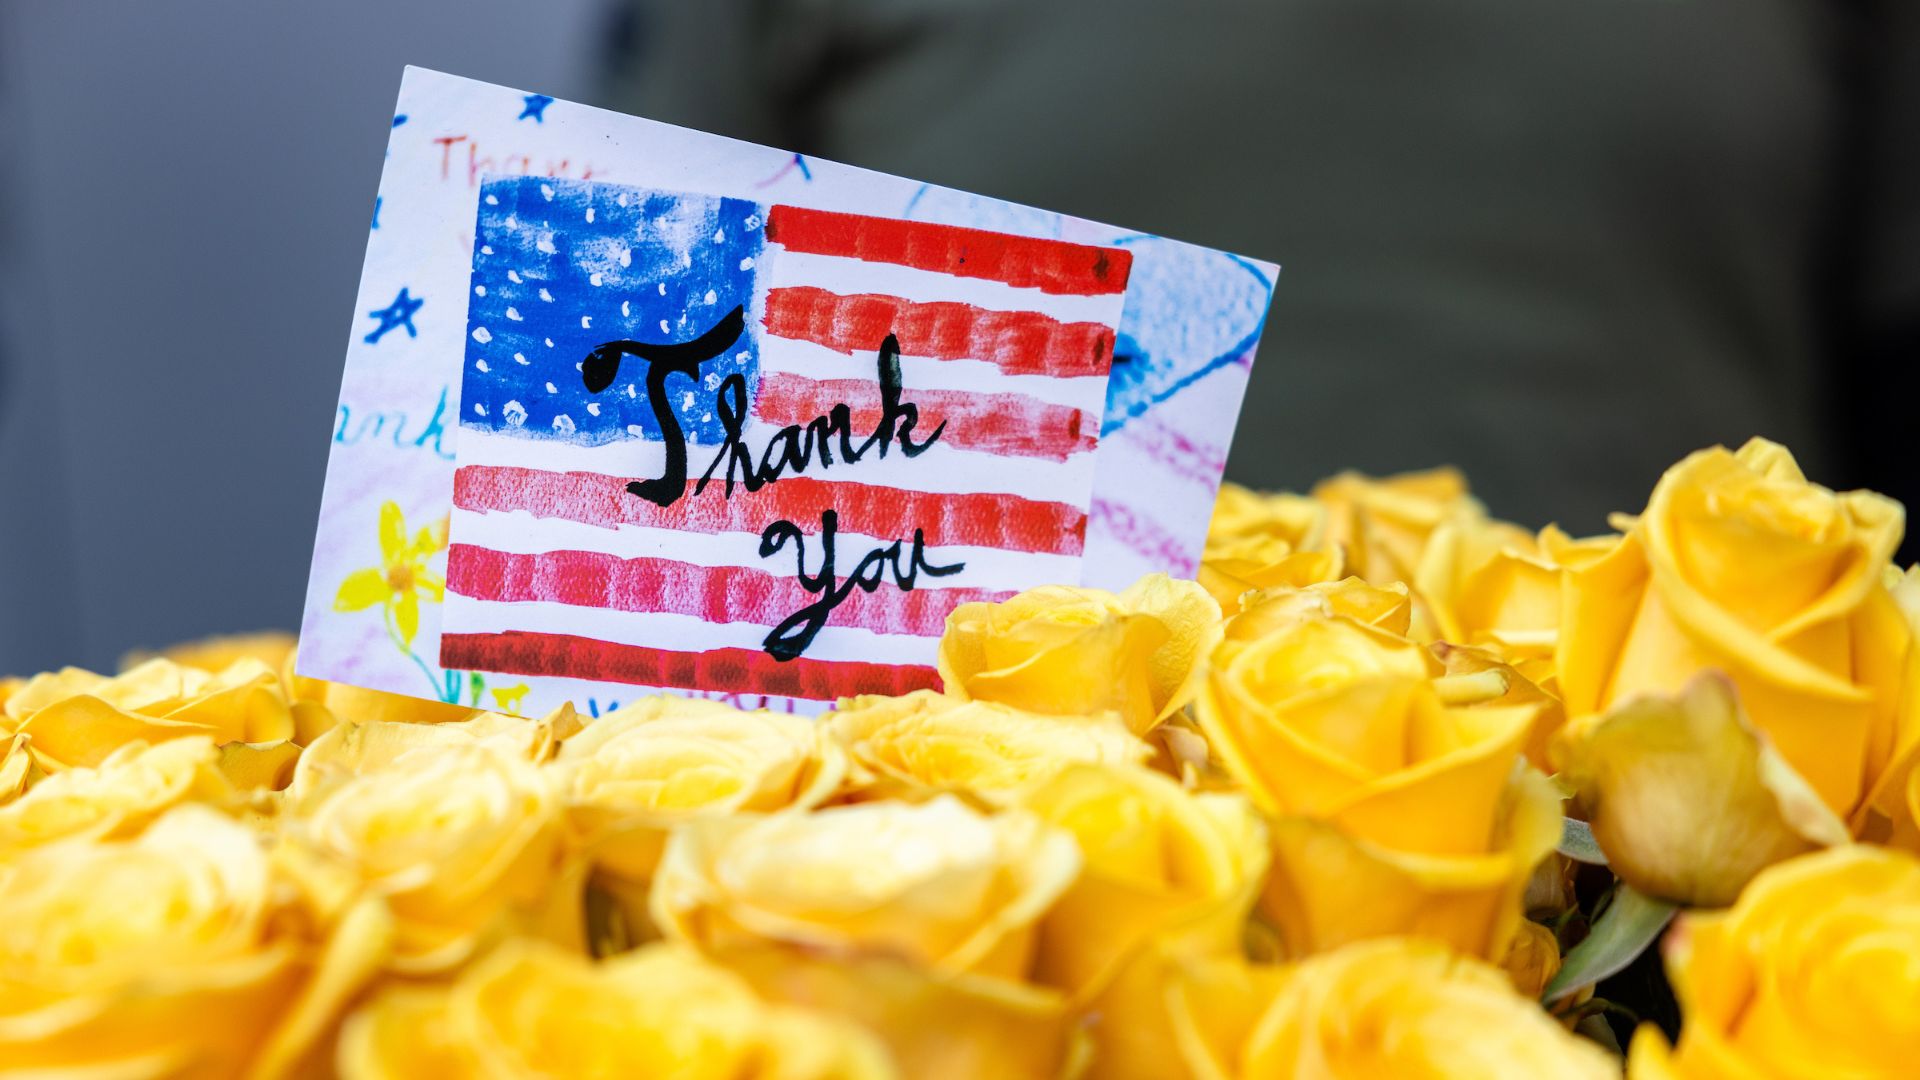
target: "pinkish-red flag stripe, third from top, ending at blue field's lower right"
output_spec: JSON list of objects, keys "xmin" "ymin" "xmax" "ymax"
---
[{"xmin": 753, "ymin": 371, "xmax": 1100, "ymax": 461}]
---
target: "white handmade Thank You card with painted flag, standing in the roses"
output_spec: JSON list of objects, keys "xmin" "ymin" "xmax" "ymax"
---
[{"xmin": 300, "ymin": 69, "xmax": 1277, "ymax": 713}]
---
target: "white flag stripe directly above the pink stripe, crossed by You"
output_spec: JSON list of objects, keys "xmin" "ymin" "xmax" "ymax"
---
[{"xmin": 449, "ymin": 507, "xmax": 1079, "ymax": 590}]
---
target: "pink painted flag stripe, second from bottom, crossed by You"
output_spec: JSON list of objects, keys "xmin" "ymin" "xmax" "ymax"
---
[{"xmin": 447, "ymin": 544, "xmax": 1012, "ymax": 638}]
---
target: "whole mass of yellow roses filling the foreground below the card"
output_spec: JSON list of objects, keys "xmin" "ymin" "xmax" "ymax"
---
[{"xmin": 0, "ymin": 432, "xmax": 1920, "ymax": 1080}]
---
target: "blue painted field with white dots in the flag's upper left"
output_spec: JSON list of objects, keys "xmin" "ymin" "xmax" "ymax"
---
[{"xmin": 461, "ymin": 177, "xmax": 764, "ymax": 446}]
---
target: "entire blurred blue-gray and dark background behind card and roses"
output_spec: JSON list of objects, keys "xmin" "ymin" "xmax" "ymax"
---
[{"xmin": 0, "ymin": 0, "xmax": 1920, "ymax": 675}]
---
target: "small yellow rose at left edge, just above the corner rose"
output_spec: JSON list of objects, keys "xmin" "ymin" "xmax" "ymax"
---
[{"xmin": 0, "ymin": 736, "xmax": 240, "ymax": 855}]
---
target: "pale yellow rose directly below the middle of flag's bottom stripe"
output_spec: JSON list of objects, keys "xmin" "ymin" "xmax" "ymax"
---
[{"xmin": 549, "ymin": 696, "xmax": 847, "ymax": 940}]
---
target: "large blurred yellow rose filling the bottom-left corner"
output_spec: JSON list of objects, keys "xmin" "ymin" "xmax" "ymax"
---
[{"xmin": 0, "ymin": 805, "xmax": 386, "ymax": 1078}]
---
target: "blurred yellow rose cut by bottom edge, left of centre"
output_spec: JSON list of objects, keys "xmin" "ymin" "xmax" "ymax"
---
[{"xmin": 338, "ymin": 940, "xmax": 897, "ymax": 1080}]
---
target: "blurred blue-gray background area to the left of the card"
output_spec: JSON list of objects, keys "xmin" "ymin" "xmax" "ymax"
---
[{"xmin": 0, "ymin": 0, "xmax": 601, "ymax": 675}]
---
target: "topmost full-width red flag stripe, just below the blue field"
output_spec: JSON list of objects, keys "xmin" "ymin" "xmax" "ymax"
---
[{"xmin": 453, "ymin": 465, "xmax": 1087, "ymax": 553}]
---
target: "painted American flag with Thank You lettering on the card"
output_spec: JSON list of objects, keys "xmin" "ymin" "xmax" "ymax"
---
[{"xmin": 440, "ymin": 177, "xmax": 1129, "ymax": 701}]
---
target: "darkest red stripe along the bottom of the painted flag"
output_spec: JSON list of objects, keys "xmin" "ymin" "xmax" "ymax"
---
[{"xmin": 440, "ymin": 630, "xmax": 941, "ymax": 701}]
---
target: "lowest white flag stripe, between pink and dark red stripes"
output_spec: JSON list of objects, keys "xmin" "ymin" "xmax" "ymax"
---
[{"xmin": 442, "ymin": 592, "xmax": 941, "ymax": 667}]
